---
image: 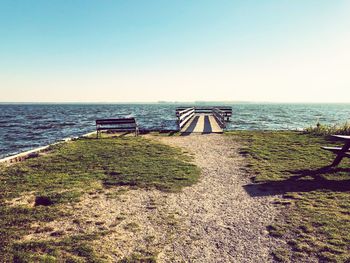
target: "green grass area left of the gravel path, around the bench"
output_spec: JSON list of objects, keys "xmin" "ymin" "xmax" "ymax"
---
[{"xmin": 0, "ymin": 137, "xmax": 200, "ymax": 262}]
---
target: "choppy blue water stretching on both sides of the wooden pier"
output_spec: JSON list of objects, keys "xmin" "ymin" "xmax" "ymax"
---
[{"xmin": 0, "ymin": 103, "xmax": 350, "ymax": 158}]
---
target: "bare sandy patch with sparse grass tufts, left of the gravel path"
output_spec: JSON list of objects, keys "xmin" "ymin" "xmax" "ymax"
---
[{"xmin": 24, "ymin": 187, "xmax": 178, "ymax": 262}]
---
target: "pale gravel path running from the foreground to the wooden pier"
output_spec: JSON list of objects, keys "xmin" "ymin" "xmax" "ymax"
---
[{"xmin": 154, "ymin": 134, "xmax": 277, "ymax": 262}]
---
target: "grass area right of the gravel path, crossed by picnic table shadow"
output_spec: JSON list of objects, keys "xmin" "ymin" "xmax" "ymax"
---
[{"xmin": 228, "ymin": 131, "xmax": 350, "ymax": 262}]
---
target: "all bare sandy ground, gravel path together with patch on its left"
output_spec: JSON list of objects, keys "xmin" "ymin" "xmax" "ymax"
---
[{"xmin": 26, "ymin": 134, "xmax": 278, "ymax": 262}]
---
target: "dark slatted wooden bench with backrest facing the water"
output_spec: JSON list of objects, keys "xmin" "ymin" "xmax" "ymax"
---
[{"xmin": 96, "ymin": 118, "xmax": 139, "ymax": 138}]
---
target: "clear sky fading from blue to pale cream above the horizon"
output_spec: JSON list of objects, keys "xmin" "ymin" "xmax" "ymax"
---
[{"xmin": 0, "ymin": 0, "xmax": 350, "ymax": 103}]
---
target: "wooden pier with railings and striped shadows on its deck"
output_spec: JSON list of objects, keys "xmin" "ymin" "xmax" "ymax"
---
[{"xmin": 176, "ymin": 106, "xmax": 232, "ymax": 134}]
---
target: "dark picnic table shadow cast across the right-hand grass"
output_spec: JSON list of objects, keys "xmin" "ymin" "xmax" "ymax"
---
[{"xmin": 243, "ymin": 166, "xmax": 350, "ymax": 197}]
